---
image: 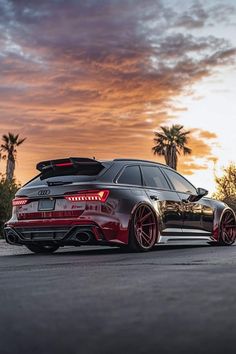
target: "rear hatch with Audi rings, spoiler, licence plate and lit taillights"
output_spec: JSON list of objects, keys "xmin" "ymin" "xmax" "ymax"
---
[{"xmin": 13, "ymin": 158, "xmax": 111, "ymax": 220}]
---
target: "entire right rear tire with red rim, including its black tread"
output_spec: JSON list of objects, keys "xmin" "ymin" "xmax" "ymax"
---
[{"xmin": 128, "ymin": 204, "xmax": 157, "ymax": 252}]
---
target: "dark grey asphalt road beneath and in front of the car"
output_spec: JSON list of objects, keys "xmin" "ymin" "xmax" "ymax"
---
[{"xmin": 0, "ymin": 241, "xmax": 236, "ymax": 354}]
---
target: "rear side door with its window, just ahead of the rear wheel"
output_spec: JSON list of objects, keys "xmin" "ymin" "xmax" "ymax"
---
[{"xmin": 141, "ymin": 165, "xmax": 183, "ymax": 236}]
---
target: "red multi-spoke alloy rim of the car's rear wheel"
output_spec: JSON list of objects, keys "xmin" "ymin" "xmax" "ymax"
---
[{"xmin": 134, "ymin": 205, "xmax": 157, "ymax": 250}]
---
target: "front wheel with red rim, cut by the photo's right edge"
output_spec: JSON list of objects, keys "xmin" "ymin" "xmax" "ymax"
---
[{"xmin": 217, "ymin": 209, "xmax": 236, "ymax": 246}]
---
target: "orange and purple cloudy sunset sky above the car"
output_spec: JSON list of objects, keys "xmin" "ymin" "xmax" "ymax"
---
[{"xmin": 0, "ymin": 0, "xmax": 236, "ymax": 191}]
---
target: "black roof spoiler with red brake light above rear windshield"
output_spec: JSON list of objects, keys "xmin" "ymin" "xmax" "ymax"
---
[{"xmin": 36, "ymin": 157, "xmax": 104, "ymax": 173}]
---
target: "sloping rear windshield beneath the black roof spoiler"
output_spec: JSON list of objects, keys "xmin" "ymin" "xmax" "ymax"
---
[{"xmin": 25, "ymin": 163, "xmax": 110, "ymax": 186}]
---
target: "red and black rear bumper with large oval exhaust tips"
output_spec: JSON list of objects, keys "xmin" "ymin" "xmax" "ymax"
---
[{"xmin": 4, "ymin": 219, "xmax": 128, "ymax": 246}]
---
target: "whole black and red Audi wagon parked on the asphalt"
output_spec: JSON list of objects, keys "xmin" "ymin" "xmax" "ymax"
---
[{"xmin": 5, "ymin": 158, "xmax": 236, "ymax": 253}]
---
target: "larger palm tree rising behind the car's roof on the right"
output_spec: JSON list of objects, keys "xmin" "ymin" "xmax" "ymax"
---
[{"xmin": 152, "ymin": 124, "xmax": 192, "ymax": 170}]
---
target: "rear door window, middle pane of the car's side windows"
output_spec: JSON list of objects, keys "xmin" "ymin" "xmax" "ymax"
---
[{"xmin": 141, "ymin": 166, "xmax": 170, "ymax": 189}]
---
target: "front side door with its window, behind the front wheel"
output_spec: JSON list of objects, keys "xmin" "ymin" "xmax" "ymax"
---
[{"xmin": 162, "ymin": 168, "xmax": 214, "ymax": 235}]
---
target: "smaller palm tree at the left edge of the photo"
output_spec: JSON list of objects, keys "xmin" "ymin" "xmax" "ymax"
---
[{"xmin": 1, "ymin": 133, "xmax": 26, "ymax": 182}]
